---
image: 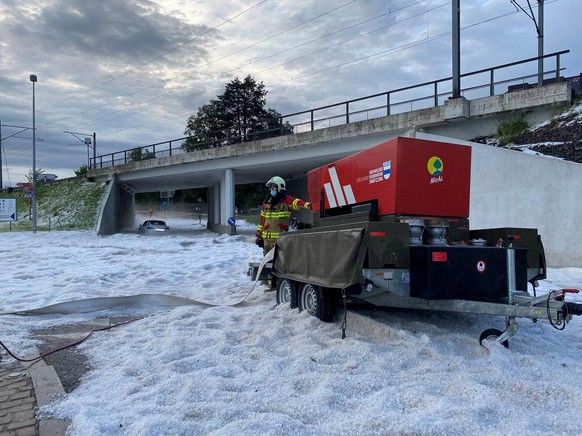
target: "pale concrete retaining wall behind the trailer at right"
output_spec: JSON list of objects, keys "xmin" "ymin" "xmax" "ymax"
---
[{"xmin": 414, "ymin": 132, "xmax": 582, "ymax": 268}]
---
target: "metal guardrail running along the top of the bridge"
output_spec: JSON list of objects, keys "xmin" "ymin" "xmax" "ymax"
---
[{"xmin": 90, "ymin": 50, "xmax": 570, "ymax": 169}]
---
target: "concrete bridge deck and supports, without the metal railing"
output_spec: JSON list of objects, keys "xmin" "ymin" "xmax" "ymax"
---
[{"xmin": 88, "ymin": 82, "xmax": 571, "ymax": 234}]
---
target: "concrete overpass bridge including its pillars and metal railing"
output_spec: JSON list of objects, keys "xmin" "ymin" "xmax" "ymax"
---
[{"xmin": 88, "ymin": 52, "xmax": 572, "ymax": 238}]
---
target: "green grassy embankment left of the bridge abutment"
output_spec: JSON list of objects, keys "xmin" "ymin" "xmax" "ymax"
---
[{"xmin": 0, "ymin": 179, "xmax": 105, "ymax": 232}]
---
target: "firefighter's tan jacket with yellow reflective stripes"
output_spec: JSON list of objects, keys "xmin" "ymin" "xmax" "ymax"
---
[{"xmin": 256, "ymin": 192, "xmax": 311, "ymax": 239}]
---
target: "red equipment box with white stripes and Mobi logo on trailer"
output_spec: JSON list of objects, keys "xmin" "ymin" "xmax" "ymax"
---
[{"xmin": 307, "ymin": 137, "xmax": 471, "ymax": 218}]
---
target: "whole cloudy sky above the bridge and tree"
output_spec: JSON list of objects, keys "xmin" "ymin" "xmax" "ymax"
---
[{"xmin": 0, "ymin": 0, "xmax": 582, "ymax": 186}]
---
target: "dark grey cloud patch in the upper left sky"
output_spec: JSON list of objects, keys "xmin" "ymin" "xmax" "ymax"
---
[{"xmin": 7, "ymin": 0, "xmax": 217, "ymax": 62}]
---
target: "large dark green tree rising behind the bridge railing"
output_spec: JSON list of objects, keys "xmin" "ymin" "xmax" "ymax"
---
[{"xmin": 182, "ymin": 75, "xmax": 293, "ymax": 151}]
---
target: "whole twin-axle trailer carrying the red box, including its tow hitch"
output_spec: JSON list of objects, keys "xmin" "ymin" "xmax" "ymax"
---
[{"xmin": 260, "ymin": 137, "xmax": 582, "ymax": 346}]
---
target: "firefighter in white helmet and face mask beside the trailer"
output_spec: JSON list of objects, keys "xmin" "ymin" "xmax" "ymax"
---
[{"xmin": 255, "ymin": 176, "xmax": 311, "ymax": 255}]
